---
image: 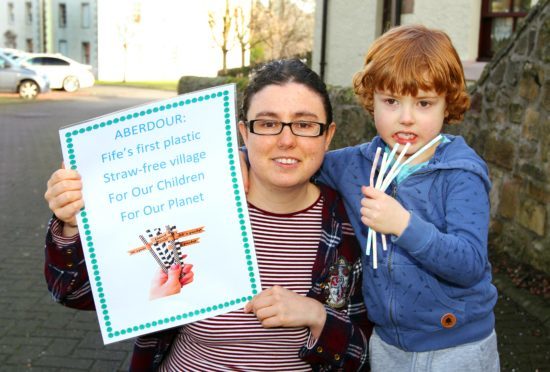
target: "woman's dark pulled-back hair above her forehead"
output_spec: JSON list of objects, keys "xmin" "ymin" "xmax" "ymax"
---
[{"xmin": 241, "ymin": 58, "xmax": 332, "ymax": 124}]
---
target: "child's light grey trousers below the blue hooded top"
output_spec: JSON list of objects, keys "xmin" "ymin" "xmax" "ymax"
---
[{"xmin": 369, "ymin": 327, "xmax": 500, "ymax": 372}]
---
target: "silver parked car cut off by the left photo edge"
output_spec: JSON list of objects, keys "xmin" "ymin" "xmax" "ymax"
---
[{"xmin": 0, "ymin": 52, "xmax": 50, "ymax": 99}]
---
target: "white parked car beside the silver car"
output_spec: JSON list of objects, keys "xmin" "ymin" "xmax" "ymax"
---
[{"xmin": 19, "ymin": 53, "xmax": 95, "ymax": 92}]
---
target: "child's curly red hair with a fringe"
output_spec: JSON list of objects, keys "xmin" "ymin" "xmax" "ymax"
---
[{"xmin": 353, "ymin": 25, "xmax": 470, "ymax": 124}]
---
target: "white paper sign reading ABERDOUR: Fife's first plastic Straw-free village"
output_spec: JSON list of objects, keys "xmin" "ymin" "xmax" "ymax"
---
[{"xmin": 60, "ymin": 84, "xmax": 261, "ymax": 344}]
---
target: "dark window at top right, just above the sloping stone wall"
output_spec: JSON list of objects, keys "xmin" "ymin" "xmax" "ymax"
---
[{"xmin": 478, "ymin": 0, "xmax": 531, "ymax": 61}]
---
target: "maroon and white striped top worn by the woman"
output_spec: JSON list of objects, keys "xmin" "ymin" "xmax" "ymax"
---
[{"xmin": 160, "ymin": 197, "xmax": 323, "ymax": 371}]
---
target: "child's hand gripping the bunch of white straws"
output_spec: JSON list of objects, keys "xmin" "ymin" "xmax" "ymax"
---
[{"xmin": 361, "ymin": 186, "xmax": 411, "ymax": 236}]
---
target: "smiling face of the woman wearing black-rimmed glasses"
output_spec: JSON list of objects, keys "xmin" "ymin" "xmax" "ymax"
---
[{"xmin": 239, "ymin": 82, "xmax": 335, "ymax": 189}]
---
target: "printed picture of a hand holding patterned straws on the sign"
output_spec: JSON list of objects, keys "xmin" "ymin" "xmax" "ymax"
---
[{"xmin": 128, "ymin": 225, "xmax": 204, "ymax": 300}]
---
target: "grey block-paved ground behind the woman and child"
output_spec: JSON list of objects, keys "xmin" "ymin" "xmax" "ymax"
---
[{"xmin": 0, "ymin": 87, "xmax": 550, "ymax": 371}]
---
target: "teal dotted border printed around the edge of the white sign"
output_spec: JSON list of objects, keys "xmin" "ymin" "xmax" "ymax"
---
[{"xmin": 65, "ymin": 90, "xmax": 258, "ymax": 338}]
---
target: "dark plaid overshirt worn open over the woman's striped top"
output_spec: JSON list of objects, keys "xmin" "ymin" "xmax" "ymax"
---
[{"xmin": 44, "ymin": 185, "xmax": 372, "ymax": 371}]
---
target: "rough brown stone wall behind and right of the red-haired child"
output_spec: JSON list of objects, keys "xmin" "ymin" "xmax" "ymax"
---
[{"xmin": 331, "ymin": 0, "xmax": 550, "ymax": 273}]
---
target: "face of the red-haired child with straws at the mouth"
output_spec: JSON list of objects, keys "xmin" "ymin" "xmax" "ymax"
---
[{"xmin": 374, "ymin": 90, "xmax": 447, "ymax": 164}]
